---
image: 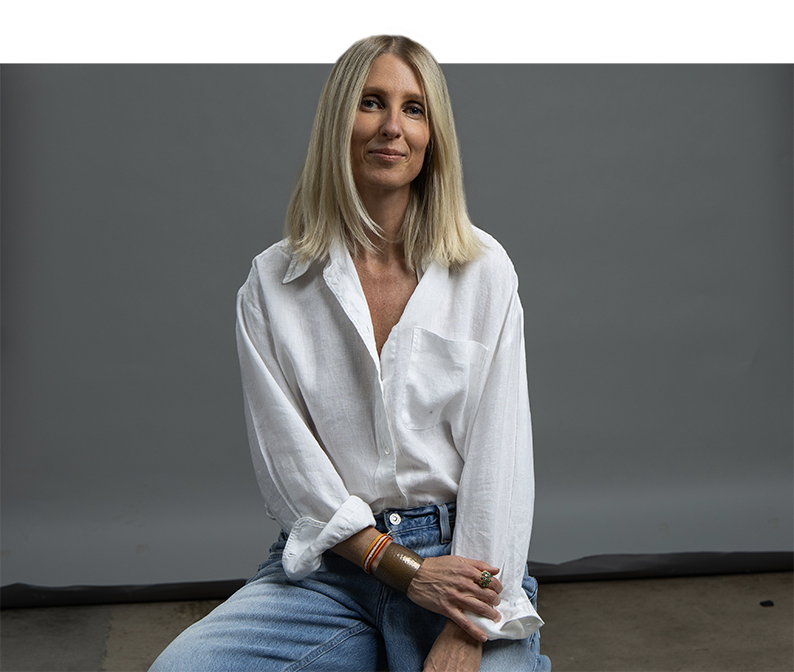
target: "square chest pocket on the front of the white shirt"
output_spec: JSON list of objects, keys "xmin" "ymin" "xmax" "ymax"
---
[{"xmin": 402, "ymin": 327, "xmax": 488, "ymax": 434}]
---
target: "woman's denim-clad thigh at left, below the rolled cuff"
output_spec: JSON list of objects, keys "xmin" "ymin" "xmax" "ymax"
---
[{"xmin": 150, "ymin": 553, "xmax": 385, "ymax": 672}]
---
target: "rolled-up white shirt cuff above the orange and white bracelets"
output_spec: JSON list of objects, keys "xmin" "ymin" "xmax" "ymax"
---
[{"xmin": 282, "ymin": 495, "xmax": 375, "ymax": 581}]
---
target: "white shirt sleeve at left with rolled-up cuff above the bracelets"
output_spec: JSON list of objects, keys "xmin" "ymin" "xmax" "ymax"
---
[{"xmin": 236, "ymin": 267, "xmax": 375, "ymax": 580}]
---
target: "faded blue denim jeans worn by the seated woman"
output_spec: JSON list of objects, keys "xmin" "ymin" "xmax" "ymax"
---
[{"xmin": 149, "ymin": 504, "xmax": 551, "ymax": 672}]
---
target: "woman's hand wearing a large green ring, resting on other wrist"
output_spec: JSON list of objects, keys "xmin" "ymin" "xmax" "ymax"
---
[{"xmin": 408, "ymin": 555, "xmax": 502, "ymax": 642}]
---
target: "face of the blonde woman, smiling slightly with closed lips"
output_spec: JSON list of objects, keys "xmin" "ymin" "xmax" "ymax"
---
[{"xmin": 350, "ymin": 54, "xmax": 430, "ymax": 201}]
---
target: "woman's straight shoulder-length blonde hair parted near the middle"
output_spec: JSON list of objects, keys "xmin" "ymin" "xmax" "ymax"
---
[{"xmin": 286, "ymin": 33, "xmax": 481, "ymax": 269}]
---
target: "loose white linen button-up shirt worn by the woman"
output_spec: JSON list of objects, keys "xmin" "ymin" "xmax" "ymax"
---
[{"xmin": 237, "ymin": 229, "xmax": 543, "ymax": 639}]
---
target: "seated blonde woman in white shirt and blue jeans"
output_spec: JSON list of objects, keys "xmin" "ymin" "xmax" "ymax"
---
[{"xmin": 152, "ymin": 34, "xmax": 550, "ymax": 672}]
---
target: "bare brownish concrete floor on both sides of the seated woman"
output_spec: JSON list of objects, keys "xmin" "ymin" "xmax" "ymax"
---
[{"xmin": 0, "ymin": 572, "xmax": 794, "ymax": 672}]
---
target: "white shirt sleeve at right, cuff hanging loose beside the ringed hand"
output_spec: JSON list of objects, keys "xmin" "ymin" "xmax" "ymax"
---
[{"xmin": 452, "ymin": 289, "xmax": 543, "ymax": 639}]
